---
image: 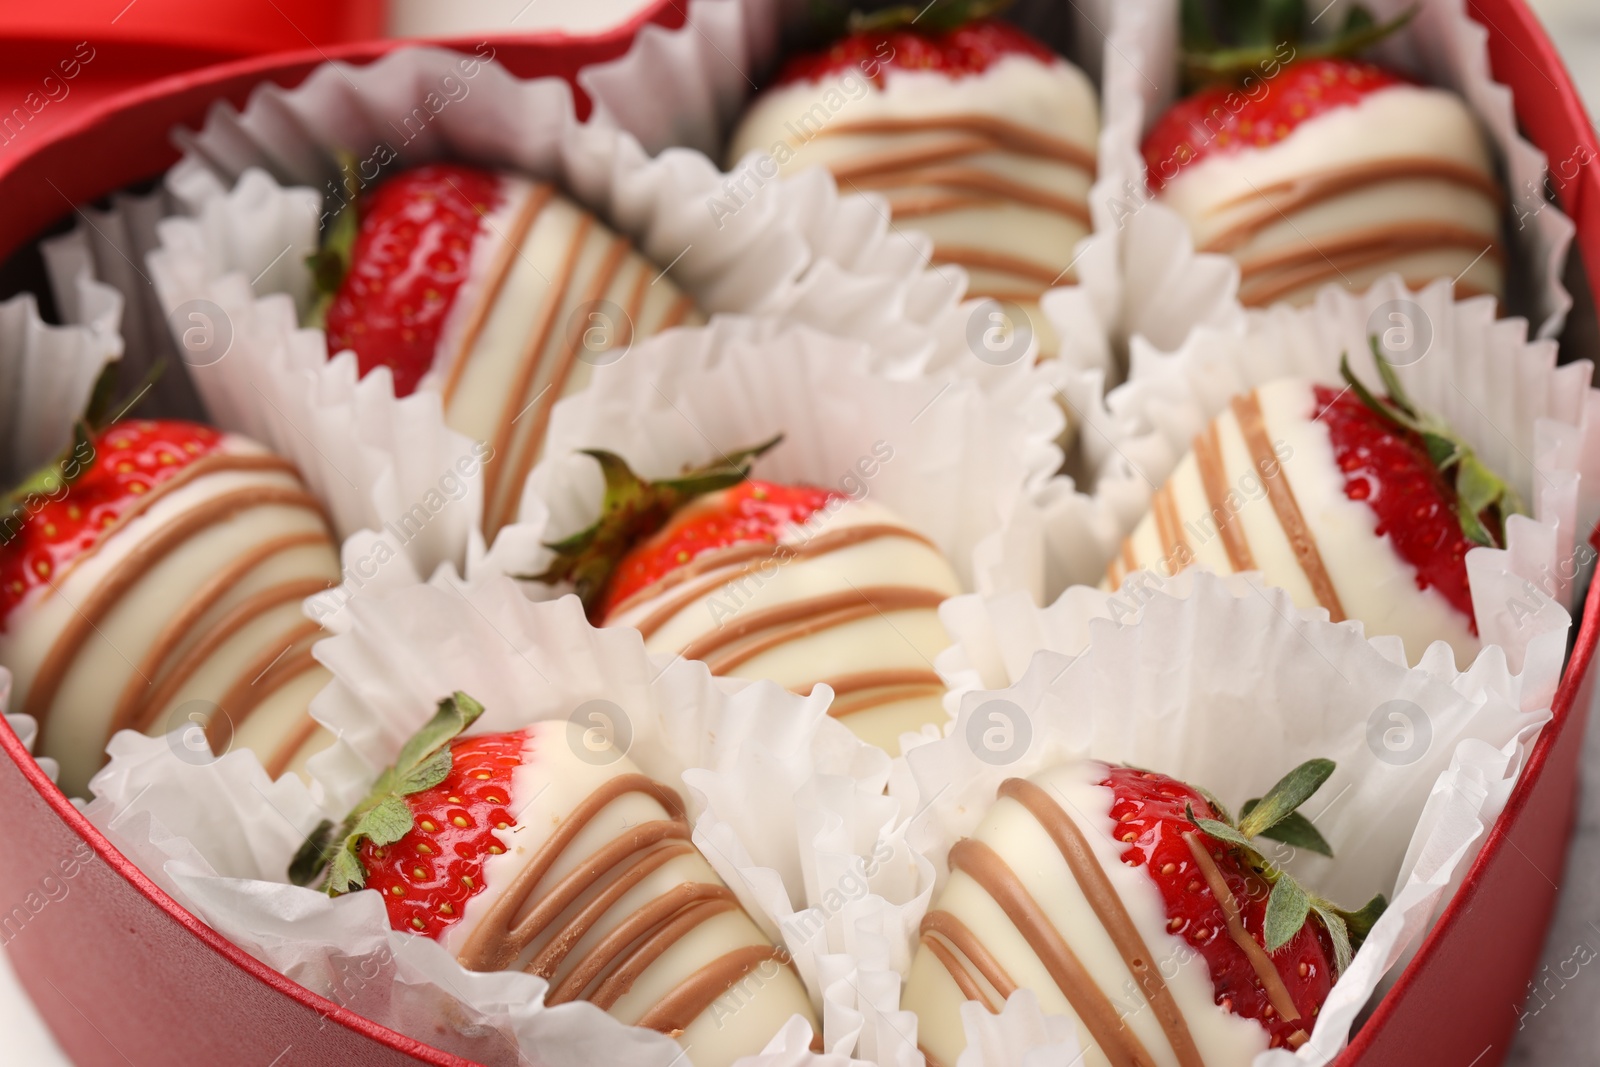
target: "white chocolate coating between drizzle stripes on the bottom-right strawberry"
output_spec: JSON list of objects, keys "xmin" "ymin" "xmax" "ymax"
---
[{"xmin": 901, "ymin": 761, "xmax": 1267, "ymax": 1067}]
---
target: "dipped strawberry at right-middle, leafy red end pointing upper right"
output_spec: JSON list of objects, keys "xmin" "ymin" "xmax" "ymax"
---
[{"xmin": 1107, "ymin": 344, "xmax": 1520, "ymax": 664}]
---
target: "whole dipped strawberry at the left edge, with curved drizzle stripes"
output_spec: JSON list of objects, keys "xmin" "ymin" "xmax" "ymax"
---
[{"xmin": 0, "ymin": 369, "xmax": 339, "ymax": 793}]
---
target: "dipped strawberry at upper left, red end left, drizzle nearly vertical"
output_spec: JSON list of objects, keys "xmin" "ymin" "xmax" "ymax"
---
[{"xmin": 310, "ymin": 163, "xmax": 701, "ymax": 536}]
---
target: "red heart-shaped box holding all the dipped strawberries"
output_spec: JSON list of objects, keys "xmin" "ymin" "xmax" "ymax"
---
[{"xmin": 0, "ymin": 0, "xmax": 1600, "ymax": 1067}]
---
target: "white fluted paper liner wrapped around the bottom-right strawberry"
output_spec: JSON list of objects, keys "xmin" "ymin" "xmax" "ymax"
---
[{"xmin": 891, "ymin": 571, "xmax": 1550, "ymax": 1067}]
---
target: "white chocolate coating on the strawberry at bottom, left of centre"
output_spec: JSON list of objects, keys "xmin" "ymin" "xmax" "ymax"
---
[{"xmin": 443, "ymin": 720, "xmax": 816, "ymax": 1067}]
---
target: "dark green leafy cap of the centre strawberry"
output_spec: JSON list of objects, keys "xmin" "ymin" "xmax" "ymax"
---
[{"xmin": 517, "ymin": 434, "xmax": 784, "ymax": 622}]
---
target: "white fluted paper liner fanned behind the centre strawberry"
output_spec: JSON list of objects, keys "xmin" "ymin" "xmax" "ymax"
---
[{"xmin": 473, "ymin": 317, "xmax": 1062, "ymax": 597}]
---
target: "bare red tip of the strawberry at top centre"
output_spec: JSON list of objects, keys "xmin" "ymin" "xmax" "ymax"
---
[{"xmin": 778, "ymin": 19, "xmax": 1056, "ymax": 85}]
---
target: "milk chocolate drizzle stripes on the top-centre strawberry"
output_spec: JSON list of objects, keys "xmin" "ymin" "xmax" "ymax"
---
[{"xmin": 813, "ymin": 114, "xmax": 1096, "ymax": 295}]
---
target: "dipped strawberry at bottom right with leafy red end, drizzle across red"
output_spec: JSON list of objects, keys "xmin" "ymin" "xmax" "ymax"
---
[{"xmin": 902, "ymin": 760, "xmax": 1384, "ymax": 1067}]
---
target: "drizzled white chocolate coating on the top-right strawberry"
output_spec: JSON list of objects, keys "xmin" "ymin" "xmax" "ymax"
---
[{"xmin": 1160, "ymin": 85, "xmax": 1506, "ymax": 306}]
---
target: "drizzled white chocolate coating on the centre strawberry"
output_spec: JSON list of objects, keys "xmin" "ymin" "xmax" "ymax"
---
[{"xmin": 606, "ymin": 501, "xmax": 962, "ymax": 755}]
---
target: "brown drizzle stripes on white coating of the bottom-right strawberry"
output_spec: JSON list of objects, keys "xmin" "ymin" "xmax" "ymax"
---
[{"xmin": 922, "ymin": 777, "xmax": 1203, "ymax": 1067}]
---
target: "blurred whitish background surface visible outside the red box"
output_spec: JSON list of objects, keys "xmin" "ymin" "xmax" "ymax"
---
[{"xmin": 0, "ymin": 0, "xmax": 1600, "ymax": 1067}]
